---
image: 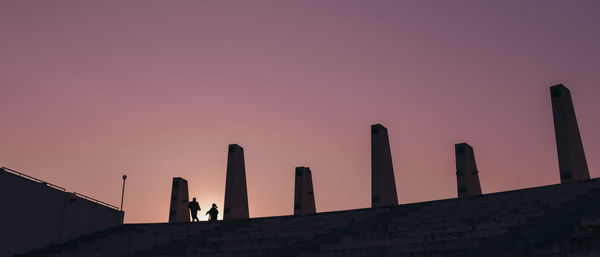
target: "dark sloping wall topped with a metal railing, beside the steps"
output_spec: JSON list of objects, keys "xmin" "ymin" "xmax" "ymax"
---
[{"xmin": 0, "ymin": 167, "xmax": 124, "ymax": 257}]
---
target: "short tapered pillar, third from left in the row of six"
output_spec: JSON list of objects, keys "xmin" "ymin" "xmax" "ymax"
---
[{"xmin": 294, "ymin": 167, "xmax": 317, "ymax": 215}]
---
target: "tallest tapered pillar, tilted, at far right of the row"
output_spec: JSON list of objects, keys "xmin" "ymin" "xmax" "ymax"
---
[{"xmin": 550, "ymin": 84, "xmax": 590, "ymax": 183}]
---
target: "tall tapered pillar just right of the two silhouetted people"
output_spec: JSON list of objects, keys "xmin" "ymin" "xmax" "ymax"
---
[{"xmin": 223, "ymin": 144, "xmax": 249, "ymax": 220}]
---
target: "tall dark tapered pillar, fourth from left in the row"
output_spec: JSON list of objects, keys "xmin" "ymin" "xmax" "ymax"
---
[{"xmin": 371, "ymin": 124, "xmax": 398, "ymax": 207}]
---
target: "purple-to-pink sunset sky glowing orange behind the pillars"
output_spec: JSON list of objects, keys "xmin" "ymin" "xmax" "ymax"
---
[{"xmin": 0, "ymin": 0, "xmax": 600, "ymax": 223}]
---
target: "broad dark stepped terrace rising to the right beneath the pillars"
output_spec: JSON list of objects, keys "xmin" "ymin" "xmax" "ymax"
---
[{"xmin": 16, "ymin": 179, "xmax": 600, "ymax": 257}]
